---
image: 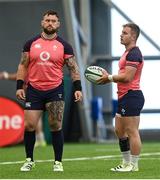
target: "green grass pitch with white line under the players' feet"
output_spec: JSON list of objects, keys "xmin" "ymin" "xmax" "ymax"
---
[{"xmin": 0, "ymin": 142, "xmax": 160, "ymax": 179}]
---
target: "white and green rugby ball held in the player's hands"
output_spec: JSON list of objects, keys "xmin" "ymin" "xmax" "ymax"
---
[{"xmin": 84, "ymin": 66, "xmax": 105, "ymax": 84}]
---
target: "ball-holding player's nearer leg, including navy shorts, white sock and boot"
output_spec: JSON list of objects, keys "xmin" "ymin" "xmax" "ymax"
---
[{"xmin": 114, "ymin": 90, "xmax": 144, "ymax": 172}]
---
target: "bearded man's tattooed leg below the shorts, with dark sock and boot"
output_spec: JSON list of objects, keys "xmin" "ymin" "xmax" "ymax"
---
[{"xmin": 46, "ymin": 100, "xmax": 64, "ymax": 171}]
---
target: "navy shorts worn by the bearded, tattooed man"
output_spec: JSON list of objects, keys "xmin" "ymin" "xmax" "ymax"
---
[{"xmin": 24, "ymin": 83, "xmax": 64, "ymax": 110}]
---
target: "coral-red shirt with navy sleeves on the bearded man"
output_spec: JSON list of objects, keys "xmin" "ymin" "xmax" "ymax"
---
[{"xmin": 23, "ymin": 35, "xmax": 74, "ymax": 91}]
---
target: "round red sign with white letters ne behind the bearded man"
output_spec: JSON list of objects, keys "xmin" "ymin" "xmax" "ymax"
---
[{"xmin": 0, "ymin": 97, "xmax": 24, "ymax": 147}]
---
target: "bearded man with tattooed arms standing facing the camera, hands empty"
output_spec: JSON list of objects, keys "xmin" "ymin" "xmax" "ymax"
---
[{"xmin": 16, "ymin": 10, "xmax": 82, "ymax": 172}]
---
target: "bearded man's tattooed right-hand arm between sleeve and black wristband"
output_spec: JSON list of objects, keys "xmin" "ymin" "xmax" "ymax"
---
[{"xmin": 66, "ymin": 57, "xmax": 80, "ymax": 81}]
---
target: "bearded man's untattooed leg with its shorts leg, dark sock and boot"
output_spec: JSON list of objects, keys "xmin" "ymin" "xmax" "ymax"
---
[{"xmin": 20, "ymin": 85, "xmax": 44, "ymax": 171}]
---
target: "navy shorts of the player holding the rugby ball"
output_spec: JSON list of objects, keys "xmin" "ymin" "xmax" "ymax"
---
[{"xmin": 117, "ymin": 90, "xmax": 145, "ymax": 116}]
